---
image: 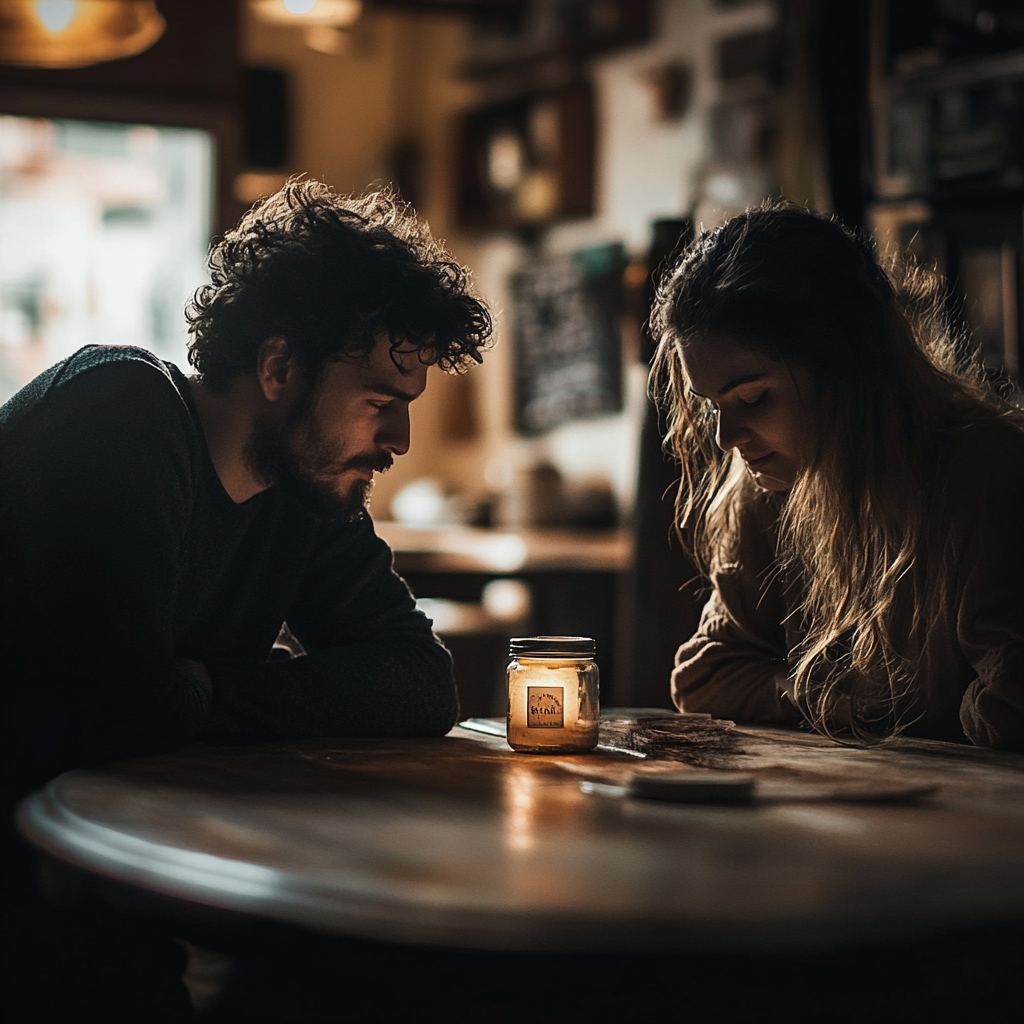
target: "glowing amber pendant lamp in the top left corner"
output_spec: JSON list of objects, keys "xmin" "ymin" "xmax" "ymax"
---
[{"xmin": 0, "ymin": 0, "xmax": 166, "ymax": 68}]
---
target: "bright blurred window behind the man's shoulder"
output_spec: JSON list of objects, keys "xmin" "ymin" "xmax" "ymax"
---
[{"xmin": 0, "ymin": 117, "xmax": 213, "ymax": 401}]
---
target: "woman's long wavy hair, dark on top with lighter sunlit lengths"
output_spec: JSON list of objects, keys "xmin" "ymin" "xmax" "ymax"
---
[{"xmin": 651, "ymin": 201, "xmax": 1024, "ymax": 741}]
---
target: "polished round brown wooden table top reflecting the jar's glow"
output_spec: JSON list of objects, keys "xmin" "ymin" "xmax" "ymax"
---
[{"xmin": 18, "ymin": 727, "xmax": 1024, "ymax": 951}]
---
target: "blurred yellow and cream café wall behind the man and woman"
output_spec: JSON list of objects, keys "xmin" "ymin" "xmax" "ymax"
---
[{"xmin": 243, "ymin": 0, "xmax": 776, "ymax": 517}]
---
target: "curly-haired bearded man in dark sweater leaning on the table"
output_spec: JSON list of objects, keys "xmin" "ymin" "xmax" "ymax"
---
[{"xmin": 0, "ymin": 174, "xmax": 490, "ymax": 823}]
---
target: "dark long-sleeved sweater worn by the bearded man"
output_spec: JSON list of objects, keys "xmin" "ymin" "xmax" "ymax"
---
[{"xmin": 0, "ymin": 346, "xmax": 457, "ymax": 799}]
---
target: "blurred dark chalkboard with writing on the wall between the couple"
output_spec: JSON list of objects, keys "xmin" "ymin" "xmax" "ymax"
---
[{"xmin": 511, "ymin": 245, "xmax": 625, "ymax": 434}]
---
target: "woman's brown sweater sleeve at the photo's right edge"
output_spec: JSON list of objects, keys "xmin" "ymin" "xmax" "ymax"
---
[{"xmin": 951, "ymin": 430, "xmax": 1024, "ymax": 750}]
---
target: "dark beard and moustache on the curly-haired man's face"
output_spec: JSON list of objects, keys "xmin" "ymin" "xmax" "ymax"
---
[{"xmin": 246, "ymin": 389, "xmax": 394, "ymax": 522}]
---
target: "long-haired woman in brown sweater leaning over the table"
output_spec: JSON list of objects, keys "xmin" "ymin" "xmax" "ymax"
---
[{"xmin": 651, "ymin": 202, "xmax": 1024, "ymax": 750}]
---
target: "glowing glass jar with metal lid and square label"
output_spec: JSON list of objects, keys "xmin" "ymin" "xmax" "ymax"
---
[{"xmin": 506, "ymin": 637, "xmax": 601, "ymax": 754}]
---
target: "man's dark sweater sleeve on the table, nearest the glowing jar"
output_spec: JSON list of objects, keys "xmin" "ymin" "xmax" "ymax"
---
[{"xmin": 203, "ymin": 515, "xmax": 459, "ymax": 738}]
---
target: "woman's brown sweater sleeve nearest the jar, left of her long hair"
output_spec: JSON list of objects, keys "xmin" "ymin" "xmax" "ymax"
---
[{"xmin": 672, "ymin": 491, "xmax": 801, "ymax": 723}]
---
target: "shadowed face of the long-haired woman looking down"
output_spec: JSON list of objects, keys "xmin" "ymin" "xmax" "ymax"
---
[{"xmin": 682, "ymin": 334, "xmax": 813, "ymax": 490}]
